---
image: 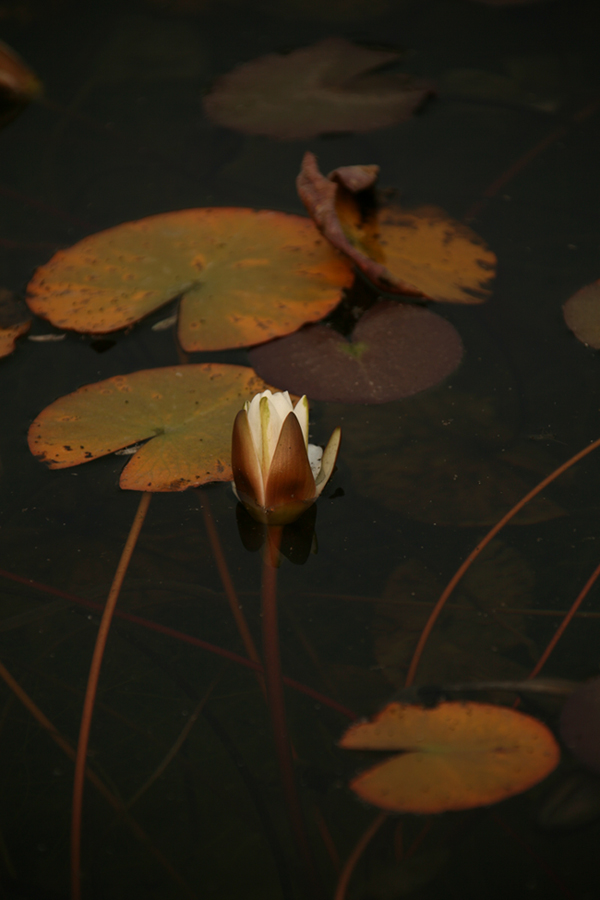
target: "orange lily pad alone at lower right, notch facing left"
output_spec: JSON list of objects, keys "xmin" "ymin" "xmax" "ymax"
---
[{"xmin": 340, "ymin": 702, "xmax": 560, "ymax": 814}]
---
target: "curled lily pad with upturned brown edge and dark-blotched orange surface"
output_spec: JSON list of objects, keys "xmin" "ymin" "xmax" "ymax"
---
[{"xmin": 297, "ymin": 152, "xmax": 496, "ymax": 303}]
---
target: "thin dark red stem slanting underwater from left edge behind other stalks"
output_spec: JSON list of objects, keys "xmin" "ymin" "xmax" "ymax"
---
[{"xmin": 0, "ymin": 569, "xmax": 358, "ymax": 720}]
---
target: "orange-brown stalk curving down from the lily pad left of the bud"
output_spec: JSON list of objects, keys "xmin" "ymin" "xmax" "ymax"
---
[{"xmin": 71, "ymin": 491, "xmax": 152, "ymax": 900}]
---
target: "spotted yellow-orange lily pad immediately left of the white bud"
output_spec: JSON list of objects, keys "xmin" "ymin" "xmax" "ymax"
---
[{"xmin": 29, "ymin": 363, "xmax": 268, "ymax": 491}]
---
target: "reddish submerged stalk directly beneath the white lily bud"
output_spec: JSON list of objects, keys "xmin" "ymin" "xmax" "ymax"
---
[{"xmin": 262, "ymin": 526, "xmax": 321, "ymax": 896}]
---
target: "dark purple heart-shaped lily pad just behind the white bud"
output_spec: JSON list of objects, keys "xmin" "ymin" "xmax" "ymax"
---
[{"xmin": 250, "ymin": 300, "xmax": 463, "ymax": 403}]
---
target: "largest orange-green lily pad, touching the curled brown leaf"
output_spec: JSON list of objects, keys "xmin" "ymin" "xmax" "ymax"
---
[{"xmin": 27, "ymin": 208, "xmax": 353, "ymax": 351}]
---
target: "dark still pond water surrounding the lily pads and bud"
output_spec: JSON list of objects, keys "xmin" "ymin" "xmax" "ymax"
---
[{"xmin": 0, "ymin": 0, "xmax": 600, "ymax": 900}]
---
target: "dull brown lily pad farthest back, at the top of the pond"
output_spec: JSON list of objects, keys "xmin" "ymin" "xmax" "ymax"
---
[{"xmin": 204, "ymin": 37, "xmax": 432, "ymax": 140}]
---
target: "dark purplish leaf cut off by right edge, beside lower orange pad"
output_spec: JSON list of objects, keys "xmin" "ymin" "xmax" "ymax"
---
[{"xmin": 560, "ymin": 678, "xmax": 600, "ymax": 773}]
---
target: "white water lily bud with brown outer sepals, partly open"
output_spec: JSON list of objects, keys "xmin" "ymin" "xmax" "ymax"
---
[{"xmin": 231, "ymin": 390, "xmax": 341, "ymax": 525}]
